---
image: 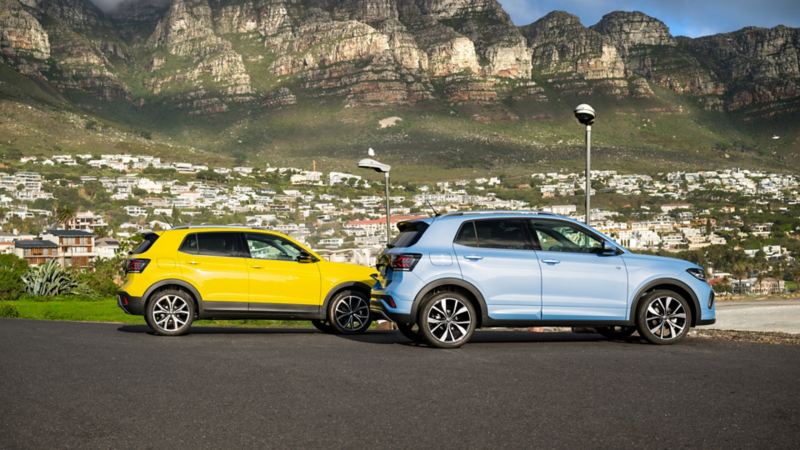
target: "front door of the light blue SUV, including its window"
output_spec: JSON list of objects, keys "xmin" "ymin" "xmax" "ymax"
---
[{"xmin": 529, "ymin": 219, "xmax": 628, "ymax": 320}]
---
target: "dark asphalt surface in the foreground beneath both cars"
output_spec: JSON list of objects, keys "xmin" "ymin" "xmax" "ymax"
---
[{"xmin": 0, "ymin": 320, "xmax": 800, "ymax": 448}]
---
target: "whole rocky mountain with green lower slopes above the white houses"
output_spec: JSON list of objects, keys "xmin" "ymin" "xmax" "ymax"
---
[{"xmin": 0, "ymin": 0, "xmax": 800, "ymax": 175}]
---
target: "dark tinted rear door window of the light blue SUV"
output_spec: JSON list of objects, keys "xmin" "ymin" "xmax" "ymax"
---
[{"xmin": 455, "ymin": 219, "xmax": 531, "ymax": 250}]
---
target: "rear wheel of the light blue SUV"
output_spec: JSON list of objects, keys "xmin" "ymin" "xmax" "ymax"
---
[{"xmin": 417, "ymin": 291, "xmax": 478, "ymax": 348}]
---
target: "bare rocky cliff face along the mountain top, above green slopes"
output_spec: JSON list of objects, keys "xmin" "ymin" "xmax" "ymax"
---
[{"xmin": 0, "ymin": 0, "xmax": 800, "ymax": 118}]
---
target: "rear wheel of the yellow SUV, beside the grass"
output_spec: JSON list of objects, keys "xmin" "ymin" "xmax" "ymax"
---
[{"xmin": 145, "ymin": 289, "xmax": 195, "ymax": 336}]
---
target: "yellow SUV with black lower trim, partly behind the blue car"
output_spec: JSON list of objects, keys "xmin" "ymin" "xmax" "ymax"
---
[{"xmin": 117, "ymin": 226, "xmax": 374, "ymax": 336}]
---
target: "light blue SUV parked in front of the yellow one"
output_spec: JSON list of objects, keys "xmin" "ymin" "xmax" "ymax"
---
[{"xmin": 370, "ymin": 212, "xmax": 715, "ymax": 348}]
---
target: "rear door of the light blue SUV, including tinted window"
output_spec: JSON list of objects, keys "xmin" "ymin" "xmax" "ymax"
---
[{"xmin": 453, "ymin": 218, "xmax": 542, "ymax": 320}]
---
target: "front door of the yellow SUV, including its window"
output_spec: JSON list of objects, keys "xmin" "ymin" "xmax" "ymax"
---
[{"xmin": 245, "ymin": 233, "xmax": 322, "ymax": 313}]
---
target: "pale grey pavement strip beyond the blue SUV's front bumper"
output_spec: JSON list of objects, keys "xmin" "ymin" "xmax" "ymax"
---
[{"xmin": 712, "ymin": 299, "xmax": 800, "ymax": 334}]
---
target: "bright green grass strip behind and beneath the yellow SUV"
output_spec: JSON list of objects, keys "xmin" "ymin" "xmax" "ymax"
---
[{"xmin": 0, "ymin": 297, "xmax": 318, "ymax": 328}]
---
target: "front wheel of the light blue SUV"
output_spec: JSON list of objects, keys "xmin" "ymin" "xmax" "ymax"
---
[{"xmin": 636, "ymin": 290, "xmax": 692, "ymax": 345}]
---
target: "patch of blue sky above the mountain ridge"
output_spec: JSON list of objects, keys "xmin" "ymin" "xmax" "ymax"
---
[{"xmin": 498, "ymin": 0, "xmax": 800, "ymax": 37}]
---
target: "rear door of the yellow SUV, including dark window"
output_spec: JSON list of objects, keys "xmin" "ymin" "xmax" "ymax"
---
[{"xmin": 177, "ymin": 231, "xmax": 249, "ymax": 311}]
